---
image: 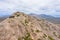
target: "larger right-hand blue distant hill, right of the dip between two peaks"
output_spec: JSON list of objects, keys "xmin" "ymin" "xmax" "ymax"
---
[{"xmin": 39, "ymin": 15, "xmax": 60, "ymax": 24}]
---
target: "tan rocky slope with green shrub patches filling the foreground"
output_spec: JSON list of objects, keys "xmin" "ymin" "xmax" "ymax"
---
[{"xmin": 0, "ymin": 12, "xmax": 60, "ymax": 40}]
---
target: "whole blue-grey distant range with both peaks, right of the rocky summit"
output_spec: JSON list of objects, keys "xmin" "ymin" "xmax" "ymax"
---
[{"xmin": 30, "ymin": 14, "xmax": 60, "ymax": 24}]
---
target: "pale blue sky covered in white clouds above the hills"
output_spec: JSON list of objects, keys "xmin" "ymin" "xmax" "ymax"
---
[{"xmin": 0, "ymin": 0, "xmax": 60, "ymax": 16}]
